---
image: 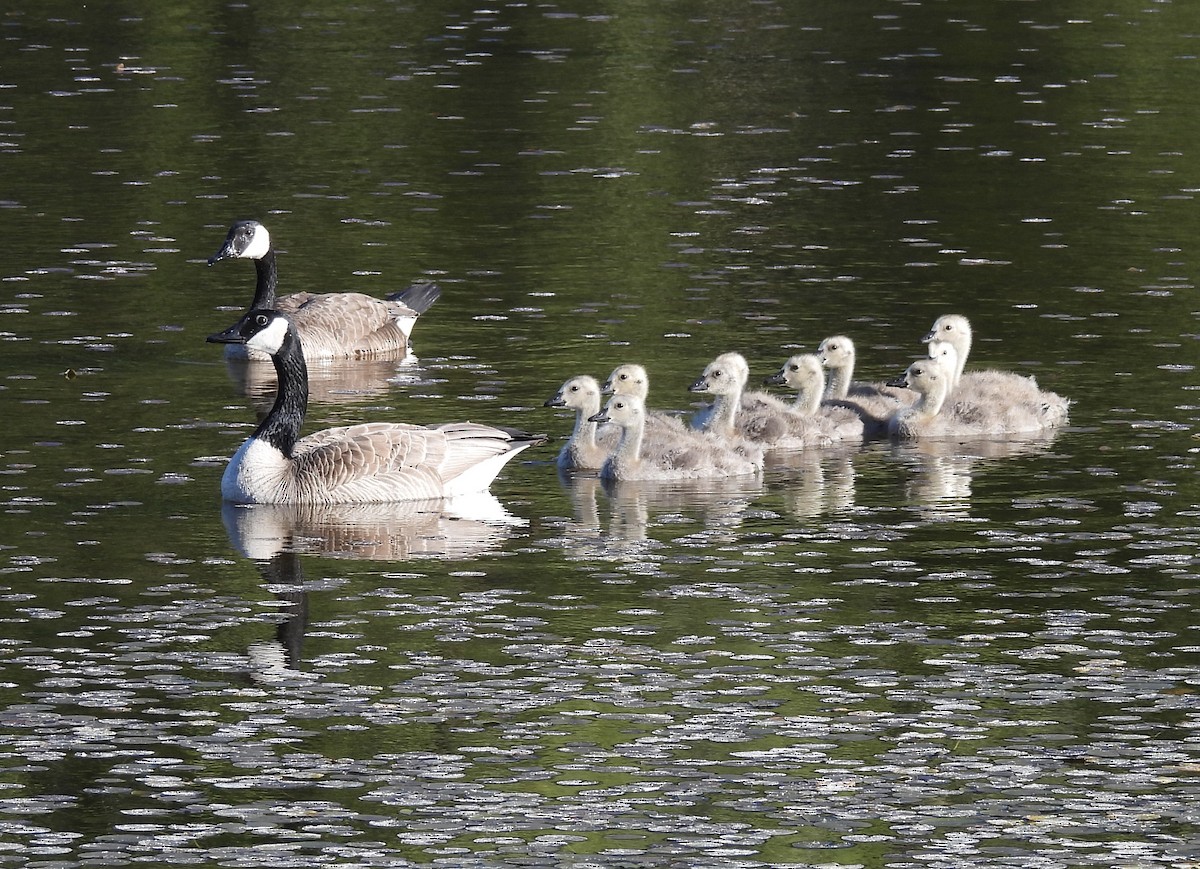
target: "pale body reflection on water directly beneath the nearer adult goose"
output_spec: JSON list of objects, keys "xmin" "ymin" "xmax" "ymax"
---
[{"xmin": 221, "ymin": 492, "xmax": 524, "ymax": 561}]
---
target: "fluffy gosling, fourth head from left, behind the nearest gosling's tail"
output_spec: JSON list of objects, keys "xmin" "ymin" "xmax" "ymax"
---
[{"xmin": 689, "ymin": 353, "xmax": 832, "ymax": 449}]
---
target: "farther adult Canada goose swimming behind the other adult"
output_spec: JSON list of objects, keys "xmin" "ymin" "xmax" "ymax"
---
[{"xmin": 209, "ymin": 220, "xmax": 442, "ymax": 361}]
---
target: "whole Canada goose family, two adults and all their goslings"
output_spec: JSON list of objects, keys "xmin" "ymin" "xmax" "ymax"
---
[{"xmin": 209, "ymin": 221, "xmax": 1069, "ymax": 504}]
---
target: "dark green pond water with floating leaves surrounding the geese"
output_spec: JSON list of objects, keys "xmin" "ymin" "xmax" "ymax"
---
[{"xmin": 0, "ymin": 0, "xmax": 1200, "ymax": 867}]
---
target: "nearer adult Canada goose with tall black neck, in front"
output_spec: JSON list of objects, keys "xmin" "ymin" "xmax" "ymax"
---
[{"xmin": 209, "ymin": 310, "xmax": 545, "ymax": 504}]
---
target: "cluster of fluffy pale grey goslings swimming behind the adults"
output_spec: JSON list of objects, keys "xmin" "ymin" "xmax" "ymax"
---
[{"xmin": 546, "ymin": 314, "xmax": 1070, "ymax": 479}]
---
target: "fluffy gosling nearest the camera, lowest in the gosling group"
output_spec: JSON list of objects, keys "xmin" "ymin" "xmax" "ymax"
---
[{"xmin": 590, "ymin": 395, "xmax": 762, "ymax": 480}]
